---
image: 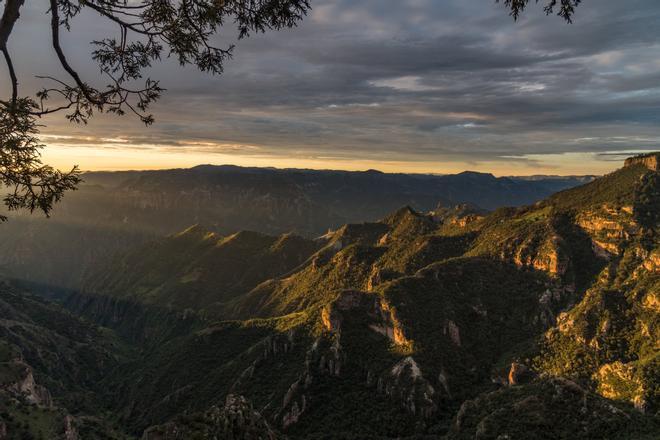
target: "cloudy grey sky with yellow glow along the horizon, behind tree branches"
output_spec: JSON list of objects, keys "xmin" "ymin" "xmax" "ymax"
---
[{"xmin": 0, "ymin": 0, "xmax": 660, "ymax": 175}]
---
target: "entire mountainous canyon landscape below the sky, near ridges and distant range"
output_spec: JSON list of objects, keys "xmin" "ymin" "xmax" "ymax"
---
[{"xmin": 0, "ymin": 153, "xmax": 660, "ymax": 440}]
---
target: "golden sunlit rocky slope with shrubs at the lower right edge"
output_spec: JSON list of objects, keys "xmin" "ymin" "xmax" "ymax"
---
[{"xmin": 537, "ymin": 231, "xmax": 660, "ymax": 412}]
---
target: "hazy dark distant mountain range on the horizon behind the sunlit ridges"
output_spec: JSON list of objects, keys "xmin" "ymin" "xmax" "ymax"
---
[{"xmin": 0, "ymin": 165, "xmax": 591, "ymax": 288}]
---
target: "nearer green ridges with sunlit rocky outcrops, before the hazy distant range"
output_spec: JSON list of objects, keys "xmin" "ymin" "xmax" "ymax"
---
[{"xmin": 2, "ymin": 156, "xmax": 660, "ymax": 440}]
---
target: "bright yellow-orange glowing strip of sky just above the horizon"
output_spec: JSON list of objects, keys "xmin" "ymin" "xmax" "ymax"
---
[{"xmin": 43, "ymin": 139, "xmax": 622, "ymax": 176}]
